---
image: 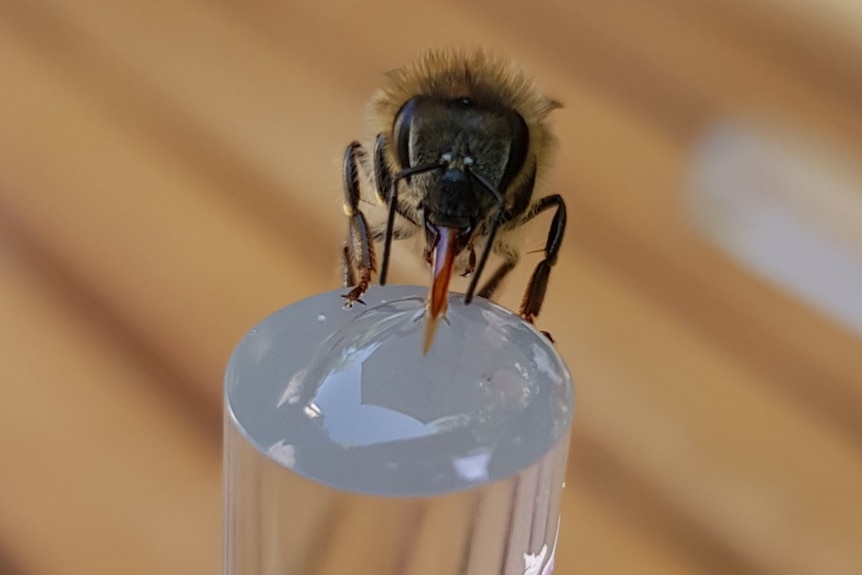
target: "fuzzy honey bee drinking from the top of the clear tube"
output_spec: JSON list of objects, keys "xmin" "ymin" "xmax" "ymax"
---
[{"xmin": 343, "ymin": 50, "xmax": 566, "ymax": 353}]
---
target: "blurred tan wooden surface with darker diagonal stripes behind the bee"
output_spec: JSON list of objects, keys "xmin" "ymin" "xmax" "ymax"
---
[{"xmin": 0, "ymin": 0, "xmax": 862, "ymax": 575}]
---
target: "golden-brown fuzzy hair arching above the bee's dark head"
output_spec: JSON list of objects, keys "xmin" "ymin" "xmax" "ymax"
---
[{"xmin": 368, "ymin": 48, "xmax": 561, "ymax": 174}]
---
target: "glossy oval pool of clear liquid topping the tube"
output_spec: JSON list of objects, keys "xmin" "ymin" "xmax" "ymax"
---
[{"xmin": 226, "ymin": 286, "xmax": 573, "ymax": 496}]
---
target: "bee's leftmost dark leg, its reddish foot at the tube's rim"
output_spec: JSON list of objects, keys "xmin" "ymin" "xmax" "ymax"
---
[{"xmin": 342, "ymin": 142, "xmax": 377, "ymax": 307}]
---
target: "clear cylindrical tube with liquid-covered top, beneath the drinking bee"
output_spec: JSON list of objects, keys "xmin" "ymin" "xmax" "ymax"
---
[{"xmin": 224, "ymin": 286, "xmax": 574, "ymax": 575}]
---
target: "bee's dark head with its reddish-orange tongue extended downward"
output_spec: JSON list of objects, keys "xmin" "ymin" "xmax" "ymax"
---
[{"xmin": 391, "ymin": 96, "xmax": 529, "ymax": 352}]
